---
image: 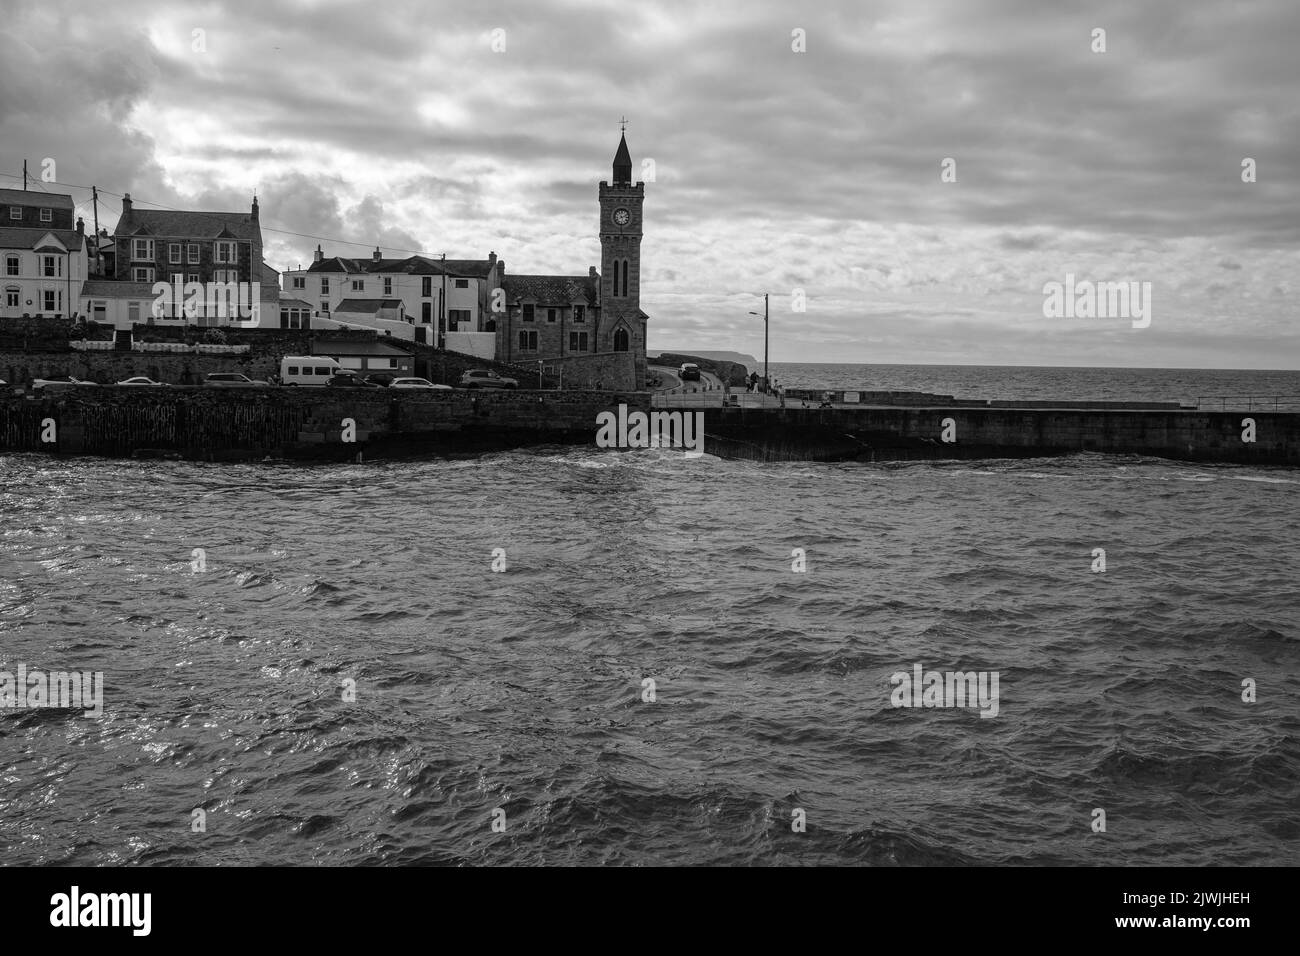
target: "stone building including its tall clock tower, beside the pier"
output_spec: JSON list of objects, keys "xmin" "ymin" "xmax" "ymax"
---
[{"xmin": 494, "ymin": 134, "xmax": 649, "ymax": 388}]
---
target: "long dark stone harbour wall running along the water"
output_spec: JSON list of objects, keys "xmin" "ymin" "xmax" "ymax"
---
[{"xmin": 0, "ymin": 386, "xmax": 1300, "ymax": 466}]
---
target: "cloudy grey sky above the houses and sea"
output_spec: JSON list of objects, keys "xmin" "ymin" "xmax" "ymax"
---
[{"xmin": 0, "ymin": 0, "xmax": 1300, "ymax": 369}]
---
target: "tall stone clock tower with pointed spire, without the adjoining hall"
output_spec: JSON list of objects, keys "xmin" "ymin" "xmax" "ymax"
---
[{"xmin": 597, "ymin": 128, "xmax": 646, "ymax": 388}]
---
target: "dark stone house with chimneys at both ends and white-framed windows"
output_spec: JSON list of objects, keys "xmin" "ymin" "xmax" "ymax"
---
[{"xmin": 105, "ymin": 194, "xmax": 280, "ymax": 325}]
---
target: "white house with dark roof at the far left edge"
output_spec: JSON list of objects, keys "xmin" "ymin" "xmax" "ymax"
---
[{"xmin": 0, "ymin": 189, "xmax": 87, "ymax": 319}]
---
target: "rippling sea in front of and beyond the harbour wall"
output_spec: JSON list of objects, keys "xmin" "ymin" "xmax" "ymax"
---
[{"xmin": 0, "ymin": 365, "xmax": 1300, "ymax": 866}]
